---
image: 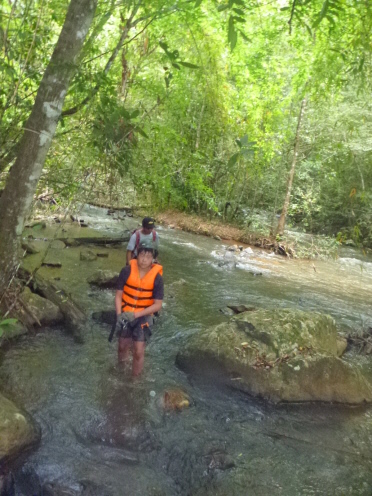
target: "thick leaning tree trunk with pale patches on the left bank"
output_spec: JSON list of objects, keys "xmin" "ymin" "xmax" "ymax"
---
[{"xmin": 0, "ymin": 0, "xmax": 98, "ymax": 298}]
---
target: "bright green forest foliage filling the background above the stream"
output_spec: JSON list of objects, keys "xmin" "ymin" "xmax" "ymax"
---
[{"xmin": 0, "ymin": 0, "xmax": 372, "ymax": 245}]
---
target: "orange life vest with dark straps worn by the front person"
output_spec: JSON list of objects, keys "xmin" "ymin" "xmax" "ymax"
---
[{"xmin": 121, "ymin": 259, "xmax": 163, "ymax": 312}]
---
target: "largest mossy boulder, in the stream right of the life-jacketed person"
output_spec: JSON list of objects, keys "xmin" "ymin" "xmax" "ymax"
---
[{"xmin": 177, "ymin": 309, "xmax": 372, "ymax": 404}]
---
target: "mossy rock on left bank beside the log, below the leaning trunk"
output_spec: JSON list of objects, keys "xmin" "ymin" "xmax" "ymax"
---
[{"xmin": 21, "ymin": 287, "xmax": 63, "ymax": 325}]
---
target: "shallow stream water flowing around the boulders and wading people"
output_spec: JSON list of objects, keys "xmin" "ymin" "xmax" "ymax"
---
[{"xmin": 0, "ymin": 204, "xmax": 372, "ymax": 496}]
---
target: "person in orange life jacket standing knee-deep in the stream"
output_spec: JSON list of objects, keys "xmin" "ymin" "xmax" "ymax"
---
[{"xmin": 115, "ymin": 243, "xmax": 164, "ymax": 376}]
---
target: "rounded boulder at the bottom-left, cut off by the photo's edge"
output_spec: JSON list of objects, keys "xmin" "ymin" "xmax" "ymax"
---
[{"xmin": 0, "ymin": 394, "xmax": 40, "ymax": 465}]
